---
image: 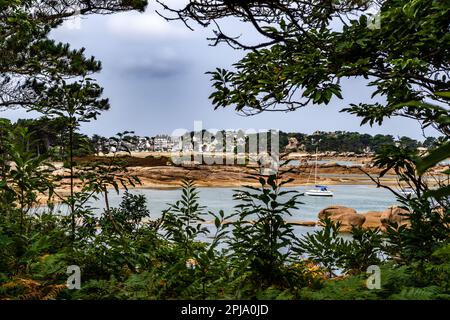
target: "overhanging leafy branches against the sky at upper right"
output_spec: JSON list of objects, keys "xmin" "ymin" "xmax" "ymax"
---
[{"xmin": 159, "ymin": 0, "xmax": 450, "ymax": 130}]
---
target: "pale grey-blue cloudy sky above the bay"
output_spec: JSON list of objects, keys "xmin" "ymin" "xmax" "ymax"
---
[{"xmin": 1, "ymin": 0, "xmax": 434, "ymax": 140}]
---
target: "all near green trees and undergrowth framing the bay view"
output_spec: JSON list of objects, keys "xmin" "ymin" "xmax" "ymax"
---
[{"xmin": 0, "ymin": 0, "xmax": 450, "ymax": 299}]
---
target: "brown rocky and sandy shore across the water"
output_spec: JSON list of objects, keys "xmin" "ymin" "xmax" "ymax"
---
[{"xmin": 37, "ymin": 153, "xmax": 449, "ymax": 202}]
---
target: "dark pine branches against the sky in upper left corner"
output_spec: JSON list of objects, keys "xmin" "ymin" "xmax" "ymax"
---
[{"xmin": 0, "ymin": 0, "xmax": 147, "ymax": 108}]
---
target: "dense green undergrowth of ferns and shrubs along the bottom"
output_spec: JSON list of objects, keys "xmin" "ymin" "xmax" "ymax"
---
[{"xmin": 0, "ymin": 168, "xmax": 450, "ymax": 299}]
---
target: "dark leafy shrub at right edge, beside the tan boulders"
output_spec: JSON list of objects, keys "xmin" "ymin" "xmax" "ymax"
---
[{"xmin": 364, "ymin": 139, "xmax": 450, "ymax": 263}]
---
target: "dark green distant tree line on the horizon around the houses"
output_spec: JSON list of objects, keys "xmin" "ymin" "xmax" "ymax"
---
[{"xmin": 0, "ymin": 117, "xmax": 438, "ymax": 158}]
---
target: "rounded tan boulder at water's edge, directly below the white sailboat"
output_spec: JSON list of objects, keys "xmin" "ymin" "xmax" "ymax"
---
[{"xmin": 319, "ymin": 206, "xmax": 366, "ymax": 232}]
